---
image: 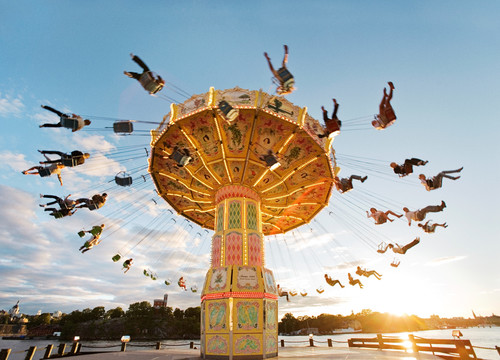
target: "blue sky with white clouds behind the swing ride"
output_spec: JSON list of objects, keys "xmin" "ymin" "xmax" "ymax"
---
[{"xmin": 0, "ymin": 0, "xmax": 500, "ymax": 316}]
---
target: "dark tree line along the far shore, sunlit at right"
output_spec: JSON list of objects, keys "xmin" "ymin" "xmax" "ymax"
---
[{"xmin": 4, "ymin": 301, "xmax": 500, "ymax": 340}]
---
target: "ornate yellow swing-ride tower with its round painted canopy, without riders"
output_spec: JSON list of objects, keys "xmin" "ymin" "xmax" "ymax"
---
[{"xmin": 149, "ymin": 87, "xmax": 334, "ymax": 359}]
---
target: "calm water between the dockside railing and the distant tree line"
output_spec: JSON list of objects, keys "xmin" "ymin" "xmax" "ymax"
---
[{"xmin": 0, "ymin": 327, "xmax": 500, "ymax": 360}]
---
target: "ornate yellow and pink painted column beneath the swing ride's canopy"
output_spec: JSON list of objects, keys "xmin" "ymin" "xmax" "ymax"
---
[{"xmin": 201, "ymin": 185, "xmax": 278, "ymax": 359}]
